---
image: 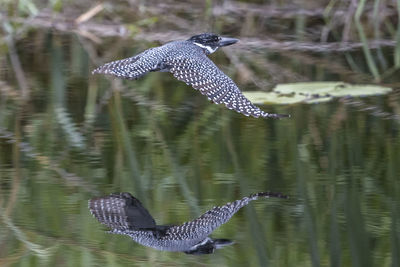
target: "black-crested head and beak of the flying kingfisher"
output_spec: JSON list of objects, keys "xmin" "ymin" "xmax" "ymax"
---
[{"xmin": 188, "ymin": 33, "xmax": 239, "ymax": 54}]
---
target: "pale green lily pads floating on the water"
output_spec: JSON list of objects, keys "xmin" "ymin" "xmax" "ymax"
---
[{"xmin": 243, "ymin": 82, "xmax": 392, "ymax": 104}]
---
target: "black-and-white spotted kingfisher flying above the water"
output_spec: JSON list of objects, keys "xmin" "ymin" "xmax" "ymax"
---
[{"xmin": 93, "ymin": 33, "xmax": 289, "ymax": 118}]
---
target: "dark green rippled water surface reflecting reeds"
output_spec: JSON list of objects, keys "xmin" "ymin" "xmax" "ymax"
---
[{"xmin": 0, "ymin": 29, "xmax": 400, "ymax": 266}]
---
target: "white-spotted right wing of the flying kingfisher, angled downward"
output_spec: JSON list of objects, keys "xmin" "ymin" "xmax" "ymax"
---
[{"xmin": 165, "ymin": 54, "xmax": 288, "ymax": 118}]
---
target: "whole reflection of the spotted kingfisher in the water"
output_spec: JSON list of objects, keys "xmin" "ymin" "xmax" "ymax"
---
[{"xmin": 89, "ymin": 192, "xmax": 287, "ymax": 254}]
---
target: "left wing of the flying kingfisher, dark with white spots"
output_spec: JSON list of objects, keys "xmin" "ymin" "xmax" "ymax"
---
[{"xmin": 92, "ymin": 47, "xmax": 161, "ymax": 80}]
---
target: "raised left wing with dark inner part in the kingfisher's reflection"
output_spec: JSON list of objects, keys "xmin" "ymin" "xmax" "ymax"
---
[{"xmin": 89, "ymin": 193, "xmax": 156, "ymax": 230}]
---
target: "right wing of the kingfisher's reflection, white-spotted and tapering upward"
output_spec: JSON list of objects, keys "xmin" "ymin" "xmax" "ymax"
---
[{"xmin": 176, "ymin": 192, "xmax": 288, "ymax": 238}]
